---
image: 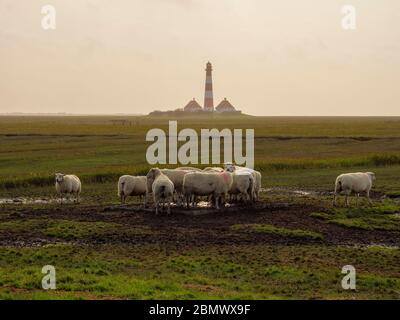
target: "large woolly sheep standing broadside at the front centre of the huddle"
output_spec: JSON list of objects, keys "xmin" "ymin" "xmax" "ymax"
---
[{"xmin": 183, "ymin": 171, "xmax": 233, "ymax": 209}]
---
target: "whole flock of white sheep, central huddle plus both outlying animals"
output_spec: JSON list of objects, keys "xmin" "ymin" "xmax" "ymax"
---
[{"xmin": 56, "ymin": 163, "xmax": 375, "ymax": 214}]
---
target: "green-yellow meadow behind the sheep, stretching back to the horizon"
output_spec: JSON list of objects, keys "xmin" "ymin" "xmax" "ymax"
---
[{"xmin": 0, "ymin": 115, "xmax": 400, "ymax": 193}]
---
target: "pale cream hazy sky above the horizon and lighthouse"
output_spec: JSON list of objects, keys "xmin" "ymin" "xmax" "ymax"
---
[{"xmin": 0, "ymin": 0, "xmax": 400, "ymax": 116}]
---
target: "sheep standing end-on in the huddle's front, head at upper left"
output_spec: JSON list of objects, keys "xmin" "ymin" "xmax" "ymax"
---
[{"xmin": 146, "ymin": 168, "xmax": 174, "ymax": 215}]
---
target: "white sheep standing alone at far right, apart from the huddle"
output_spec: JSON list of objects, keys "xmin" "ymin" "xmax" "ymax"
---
[{"xmin": 333, "ymin": 172, "xmax": 375, "ymax": 206}]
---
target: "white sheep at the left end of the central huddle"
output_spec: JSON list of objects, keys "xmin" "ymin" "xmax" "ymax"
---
[{"xmin": 118, "ymin": 175, "xmax": 147, "ymax": 206}]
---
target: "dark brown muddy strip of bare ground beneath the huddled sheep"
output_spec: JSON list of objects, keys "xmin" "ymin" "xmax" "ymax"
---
[{"xmin": 0, "ymin": 203, "xmax": 400, "ymax": 249}]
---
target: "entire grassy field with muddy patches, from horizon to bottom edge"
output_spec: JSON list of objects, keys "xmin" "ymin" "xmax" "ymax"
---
[{"xmin": 0, "ymin": 115, "xmax": 400, "ymax": 299}]
